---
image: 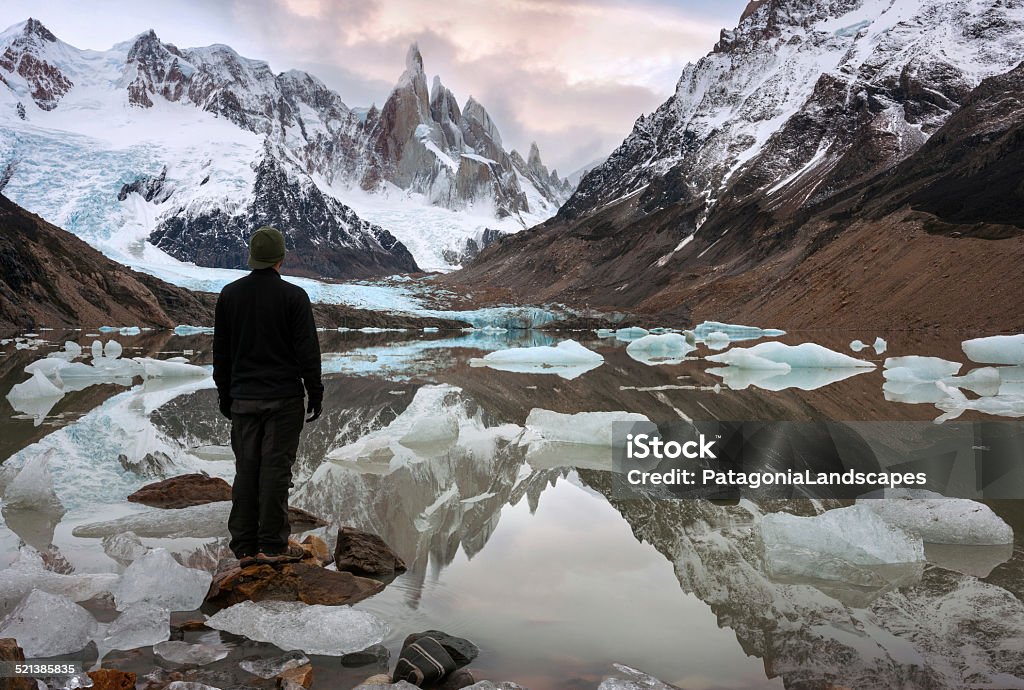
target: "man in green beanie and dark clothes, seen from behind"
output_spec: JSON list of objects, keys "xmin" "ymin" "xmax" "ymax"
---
[{"xmin": 213, "ymin": 227, "xmax": 324, "ymax": 567}]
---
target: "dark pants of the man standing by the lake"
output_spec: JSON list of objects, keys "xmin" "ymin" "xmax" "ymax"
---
[{"xmin": 227, "ymin": 397, "xmax": 305, "ymax": 557}]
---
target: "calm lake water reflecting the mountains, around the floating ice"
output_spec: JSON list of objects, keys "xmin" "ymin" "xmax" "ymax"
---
[{"xmin": 0, "ymin": 325, "xmax": 1024, "ymax": 688}]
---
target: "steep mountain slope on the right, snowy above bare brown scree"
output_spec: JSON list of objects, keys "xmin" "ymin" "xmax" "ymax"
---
[{"xmin": 451, "ymin": 0, "xmax": 1024, "ymax": 328}]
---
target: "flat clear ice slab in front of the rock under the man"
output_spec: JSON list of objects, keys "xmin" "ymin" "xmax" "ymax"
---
[{"xmin": 206, "ymin": 601, "xmax": 390, "ymax": 656}]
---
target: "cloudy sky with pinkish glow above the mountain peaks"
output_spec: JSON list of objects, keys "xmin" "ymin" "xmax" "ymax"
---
[{"xmin": 0, "ymin": 0, "xmax": 746, "ymax": 174}]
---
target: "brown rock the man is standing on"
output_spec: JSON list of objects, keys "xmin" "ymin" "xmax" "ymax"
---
[{"xmin": 206, "ymin": 562, "xmax": 384, "ymax": 607}]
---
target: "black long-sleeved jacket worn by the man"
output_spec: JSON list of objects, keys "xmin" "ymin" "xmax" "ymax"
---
[{"xmin": 213, "ymin": 268, "xmax": 324, "ymax": 402}]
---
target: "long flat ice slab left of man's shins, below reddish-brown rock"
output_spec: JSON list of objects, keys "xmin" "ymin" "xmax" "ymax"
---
[{"xmin": 72, "ymin": 501, "xmax": 231, "ymax": 538}]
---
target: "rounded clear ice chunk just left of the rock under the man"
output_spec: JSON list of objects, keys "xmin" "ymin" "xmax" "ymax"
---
[{"xmin": 114, "ymin": 544, "xmax": 213, "ymax": 611}]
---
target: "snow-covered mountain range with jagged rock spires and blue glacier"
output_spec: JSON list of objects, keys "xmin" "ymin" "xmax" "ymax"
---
[{"xmin": 0, "ymin": 19, "xmax": 570, "ymax": 277}]
